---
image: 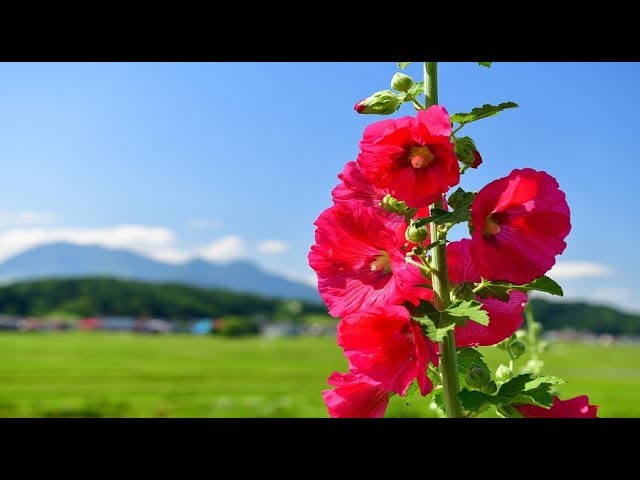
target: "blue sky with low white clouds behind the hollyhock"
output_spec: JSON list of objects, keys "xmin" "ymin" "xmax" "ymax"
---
[{"xmin": 0, "ymin": 59, "xmax": 640, "ymax": 311}]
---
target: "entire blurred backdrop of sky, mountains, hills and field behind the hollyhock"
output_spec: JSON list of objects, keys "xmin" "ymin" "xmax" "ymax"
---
[{"xmin": 0, "ymin": 59, "xmax": 640, "ymax": 417}]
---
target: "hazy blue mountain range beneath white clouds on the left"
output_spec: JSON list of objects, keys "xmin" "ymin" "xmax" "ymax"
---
[{"xmin": 0, "ymin": 243, "xmax": 320, "ymax": 302}]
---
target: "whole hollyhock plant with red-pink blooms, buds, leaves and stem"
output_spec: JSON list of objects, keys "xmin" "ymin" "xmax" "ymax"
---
[{"xmin": 309, "ymin": 62, "xmax": 597, "ymax": 418}]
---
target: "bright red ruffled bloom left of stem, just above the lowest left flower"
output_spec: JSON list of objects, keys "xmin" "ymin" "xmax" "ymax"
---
[{"xmin": 338, "ymin": 305, "xmax": 438, "ymax": 395}]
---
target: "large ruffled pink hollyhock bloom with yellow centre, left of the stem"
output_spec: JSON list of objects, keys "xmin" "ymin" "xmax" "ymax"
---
[{"xmin": 309, "ymin": 203, "xmax": 431, "ymax": 317}]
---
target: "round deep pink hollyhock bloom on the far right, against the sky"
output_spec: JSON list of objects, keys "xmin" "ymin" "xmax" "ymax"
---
[{"xmin": 471, "ymin": 168, "xmax": 571, "ymax": 285}]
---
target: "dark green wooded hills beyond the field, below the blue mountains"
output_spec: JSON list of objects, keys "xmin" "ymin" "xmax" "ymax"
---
[{"xmin": 0, "ymin": 278, "xmax": 640, "ymax": 335}]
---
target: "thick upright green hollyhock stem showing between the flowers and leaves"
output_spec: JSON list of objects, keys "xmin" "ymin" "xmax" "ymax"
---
[{"xmin": 424, "ymin": 62, "xmax": 462, "ymax": 418}]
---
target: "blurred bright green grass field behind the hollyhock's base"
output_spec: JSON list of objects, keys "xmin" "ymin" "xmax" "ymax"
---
[{"xmin": 0, "ymin": 332, "xmax": 640, "ymax": 417}]
